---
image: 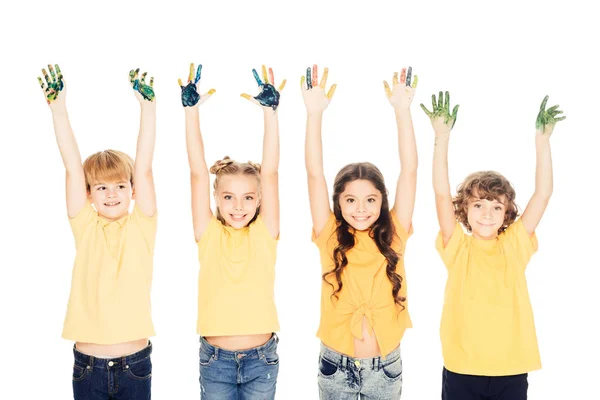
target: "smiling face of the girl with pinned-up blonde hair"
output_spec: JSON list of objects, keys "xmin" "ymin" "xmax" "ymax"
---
[{"xmin": 214, "ymin": 174, "xmax": 260, "ymax": 229}]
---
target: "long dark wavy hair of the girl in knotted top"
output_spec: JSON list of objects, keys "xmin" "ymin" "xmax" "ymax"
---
[{"xmin": 323, "ymin": 162, "xmax": 406, "ymax": 310}]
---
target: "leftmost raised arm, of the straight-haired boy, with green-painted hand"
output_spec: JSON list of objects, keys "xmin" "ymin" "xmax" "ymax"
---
[{"xmin": 38, "ymin": 64, "xmax": 87, "ymax": 218}]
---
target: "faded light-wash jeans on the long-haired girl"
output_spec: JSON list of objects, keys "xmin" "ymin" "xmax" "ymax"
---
[{"xmin": 317, "ymin": 344, "xmax": 402, "ymax": 400}]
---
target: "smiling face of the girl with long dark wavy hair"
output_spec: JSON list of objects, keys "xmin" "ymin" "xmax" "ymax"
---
[{"xmin": 339, "ymin": 179, "xmax": 382, "ymax": 231}]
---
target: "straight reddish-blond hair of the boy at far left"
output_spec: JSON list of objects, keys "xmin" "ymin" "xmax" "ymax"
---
[{"xmin": 83, "ymin": 150, "xmax": 134, "ymax": 192}]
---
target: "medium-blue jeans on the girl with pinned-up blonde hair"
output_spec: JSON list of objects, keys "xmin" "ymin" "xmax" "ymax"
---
[{"xmin": 200, "ymin": 334, "xmax": 279, "ymax": 400}]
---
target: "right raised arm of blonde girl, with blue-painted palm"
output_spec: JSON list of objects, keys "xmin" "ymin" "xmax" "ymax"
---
[{"xmin": 241, "ymin": 65, "xmax": 285, "ymax": 238}]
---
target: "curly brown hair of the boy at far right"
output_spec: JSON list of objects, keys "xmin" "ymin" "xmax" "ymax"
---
[{"xmin": 452, "ymin": 171, "xmax": 519, "ymax": 234}]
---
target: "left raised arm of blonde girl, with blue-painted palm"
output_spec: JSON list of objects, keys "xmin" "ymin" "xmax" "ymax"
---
[{"xmin": 179, "ymin": 64, "xmax": 215, "ymax": 241}]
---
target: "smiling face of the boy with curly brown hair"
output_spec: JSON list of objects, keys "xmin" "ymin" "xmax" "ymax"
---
[{"xmin": 467, "ymin": 192, "xmax": 506, "ymax": 240}]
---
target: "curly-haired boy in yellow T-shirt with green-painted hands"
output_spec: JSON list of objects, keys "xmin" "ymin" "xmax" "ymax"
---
[{"xmin": 421, "ymin": 92, "xmax": 565, "ymax": 400}]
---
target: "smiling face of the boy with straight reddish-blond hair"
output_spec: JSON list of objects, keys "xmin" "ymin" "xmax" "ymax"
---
[{"xmin": 88, "ymin": 181, "xmax": 134, "ymax": 221}]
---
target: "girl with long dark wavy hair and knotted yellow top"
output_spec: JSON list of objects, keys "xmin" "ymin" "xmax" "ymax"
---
[{"xmin": 301, "ymin": 65, "xmax": 417, "ymax": 400}]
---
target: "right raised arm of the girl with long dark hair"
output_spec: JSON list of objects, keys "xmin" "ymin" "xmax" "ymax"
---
[{"xmin": 383, "ymin": 67, "xmax": 419, "ymax": 232}]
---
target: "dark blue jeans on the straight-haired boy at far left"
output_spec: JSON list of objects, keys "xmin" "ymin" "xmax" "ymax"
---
[{"xmin": 73, "ymin": 343, "xmax": 152, "ymax": 400}]
